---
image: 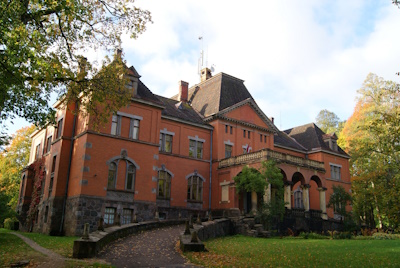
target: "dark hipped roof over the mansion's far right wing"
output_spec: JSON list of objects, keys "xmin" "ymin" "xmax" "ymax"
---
[{"xmin": 284, "ymin": 123, "xmax": 349, "ymax": 157}]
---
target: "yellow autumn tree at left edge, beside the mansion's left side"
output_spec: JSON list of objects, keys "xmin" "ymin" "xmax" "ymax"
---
[{"xmin": 0, "ymin": 125, "xmax": 35, "ymax": 223}]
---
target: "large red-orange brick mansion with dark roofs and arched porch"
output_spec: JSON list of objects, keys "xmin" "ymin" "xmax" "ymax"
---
[{"xmin": 17, "ymin": 57, "xmax": 350, "ymax": 235}]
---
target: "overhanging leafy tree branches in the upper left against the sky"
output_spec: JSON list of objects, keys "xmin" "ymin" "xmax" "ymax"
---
[{"xmin": 0, "ymin": 0, "xmax": 151, "ymax": 144}]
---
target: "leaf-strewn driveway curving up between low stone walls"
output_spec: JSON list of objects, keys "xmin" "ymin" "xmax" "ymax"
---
[{"xmin": 97, "ymin": 225, "xmax": 196, "ymax": 267}]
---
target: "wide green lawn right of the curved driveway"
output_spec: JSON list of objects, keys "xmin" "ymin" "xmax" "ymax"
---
[{"xmin": 185, "ymin": 236, "xmax": 400, "ymax": 267}]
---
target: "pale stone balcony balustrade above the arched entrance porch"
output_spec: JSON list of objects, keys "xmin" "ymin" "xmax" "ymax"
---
[{"xmin": 218, "ymin": 149, "xmax": 325, "ymax": 172}]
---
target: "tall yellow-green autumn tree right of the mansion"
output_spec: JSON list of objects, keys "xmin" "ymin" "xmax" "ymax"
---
[{"xmin": 340, "ymin": 74, "xmax": 400, "ymax": 228}]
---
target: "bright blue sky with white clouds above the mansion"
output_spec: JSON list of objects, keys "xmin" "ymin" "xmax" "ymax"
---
[{"xmin": 4, "ymin": 0, "xmax": 400, "ymax": 132}]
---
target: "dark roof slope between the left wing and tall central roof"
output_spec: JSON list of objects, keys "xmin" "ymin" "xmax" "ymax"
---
[{"xmin": 157, "ymin": 96, "xmax": 209, "ymax": 126}]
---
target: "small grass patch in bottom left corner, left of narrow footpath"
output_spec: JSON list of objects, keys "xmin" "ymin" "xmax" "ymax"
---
[{"xmin": 0, "ymin": 228, "xmax": 46, "ymax": 267}]
